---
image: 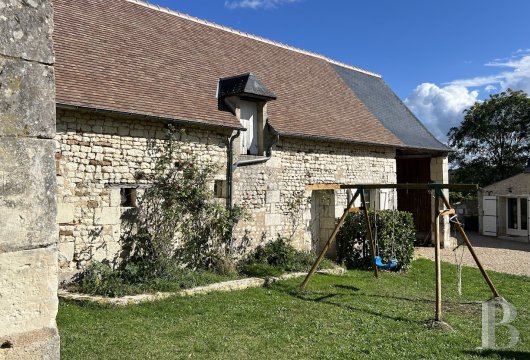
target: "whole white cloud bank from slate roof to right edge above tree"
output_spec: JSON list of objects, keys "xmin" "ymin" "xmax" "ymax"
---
[{"xmin": 405, "ymin": 49, "xmax": 530, "ymax": 142}]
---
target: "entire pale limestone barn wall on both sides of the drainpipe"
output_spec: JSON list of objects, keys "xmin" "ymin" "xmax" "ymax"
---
[{"xmin": 55, "ymin": 109, "xmax": 395, "ymax": 279}]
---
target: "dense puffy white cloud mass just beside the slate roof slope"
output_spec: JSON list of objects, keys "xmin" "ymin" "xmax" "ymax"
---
[{"xmin": 405, "ymin": 83, "xmax": 479, "ymax": 142}]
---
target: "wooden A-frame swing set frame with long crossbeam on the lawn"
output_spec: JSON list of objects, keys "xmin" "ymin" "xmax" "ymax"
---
[{"xmin": 300, "ymin": 183, "xmax": 500, "ymax": 322}]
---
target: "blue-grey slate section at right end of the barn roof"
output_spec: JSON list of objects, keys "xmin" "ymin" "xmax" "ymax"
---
[{"xmin": 333, "ymin": 65, "xmax": 451, "ymax": 151}]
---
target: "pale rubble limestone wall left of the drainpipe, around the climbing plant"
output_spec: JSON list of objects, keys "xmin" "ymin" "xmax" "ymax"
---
[{"xmin": 55, "ymin": 109, "xmax": 229, "ymax": 279}]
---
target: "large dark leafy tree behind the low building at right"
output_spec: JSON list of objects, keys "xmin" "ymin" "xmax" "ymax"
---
[{"xmin": 447, "ymin": 89, "xmax": 530, "ymax": 186}]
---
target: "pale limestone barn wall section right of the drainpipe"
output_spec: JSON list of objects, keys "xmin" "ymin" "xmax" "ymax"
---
[{"xmin": 234, "ymin": 138, "xmax": 396, "ymax": 250}]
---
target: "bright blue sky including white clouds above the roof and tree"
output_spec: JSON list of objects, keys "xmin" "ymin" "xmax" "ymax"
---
[{"xmin": 143, "ymin": 0, "xmax": 530, "ymax": 141}]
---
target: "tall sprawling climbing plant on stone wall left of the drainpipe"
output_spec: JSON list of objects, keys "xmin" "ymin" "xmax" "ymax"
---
[{"xmin": 121, "ymin": 128, "xmax": 243, "ymax": 273}]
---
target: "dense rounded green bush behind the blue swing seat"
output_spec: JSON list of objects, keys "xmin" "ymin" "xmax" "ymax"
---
[{"xmin": 337, "ymin": 210, "xmax": 416, "ymax": 269}]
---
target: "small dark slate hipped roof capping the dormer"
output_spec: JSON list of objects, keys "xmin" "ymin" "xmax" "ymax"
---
[{"xmin": 218, "ymin": 73, "xmax": 276, "ymax": 100}]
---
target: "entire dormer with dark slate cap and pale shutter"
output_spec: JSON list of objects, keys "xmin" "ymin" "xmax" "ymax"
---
[{"xmin": 218, "ymin": 73, "xmax": 276, "ymax": 155}]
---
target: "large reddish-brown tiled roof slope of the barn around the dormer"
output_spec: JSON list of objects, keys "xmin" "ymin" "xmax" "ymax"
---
[{"xmin": 54, "ymin": 0, "xmax": 403, "ymax": 146}]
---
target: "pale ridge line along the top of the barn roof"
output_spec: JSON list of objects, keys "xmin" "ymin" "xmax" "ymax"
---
[{"xmin": 126, "ymin": 0, "xmax": 381, "ymax": 78}]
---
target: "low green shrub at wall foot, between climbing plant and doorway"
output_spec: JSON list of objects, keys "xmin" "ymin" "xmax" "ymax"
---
[{"xmin": 241, "ymin": 235, "xmax": 322, "ymax": 272}]
